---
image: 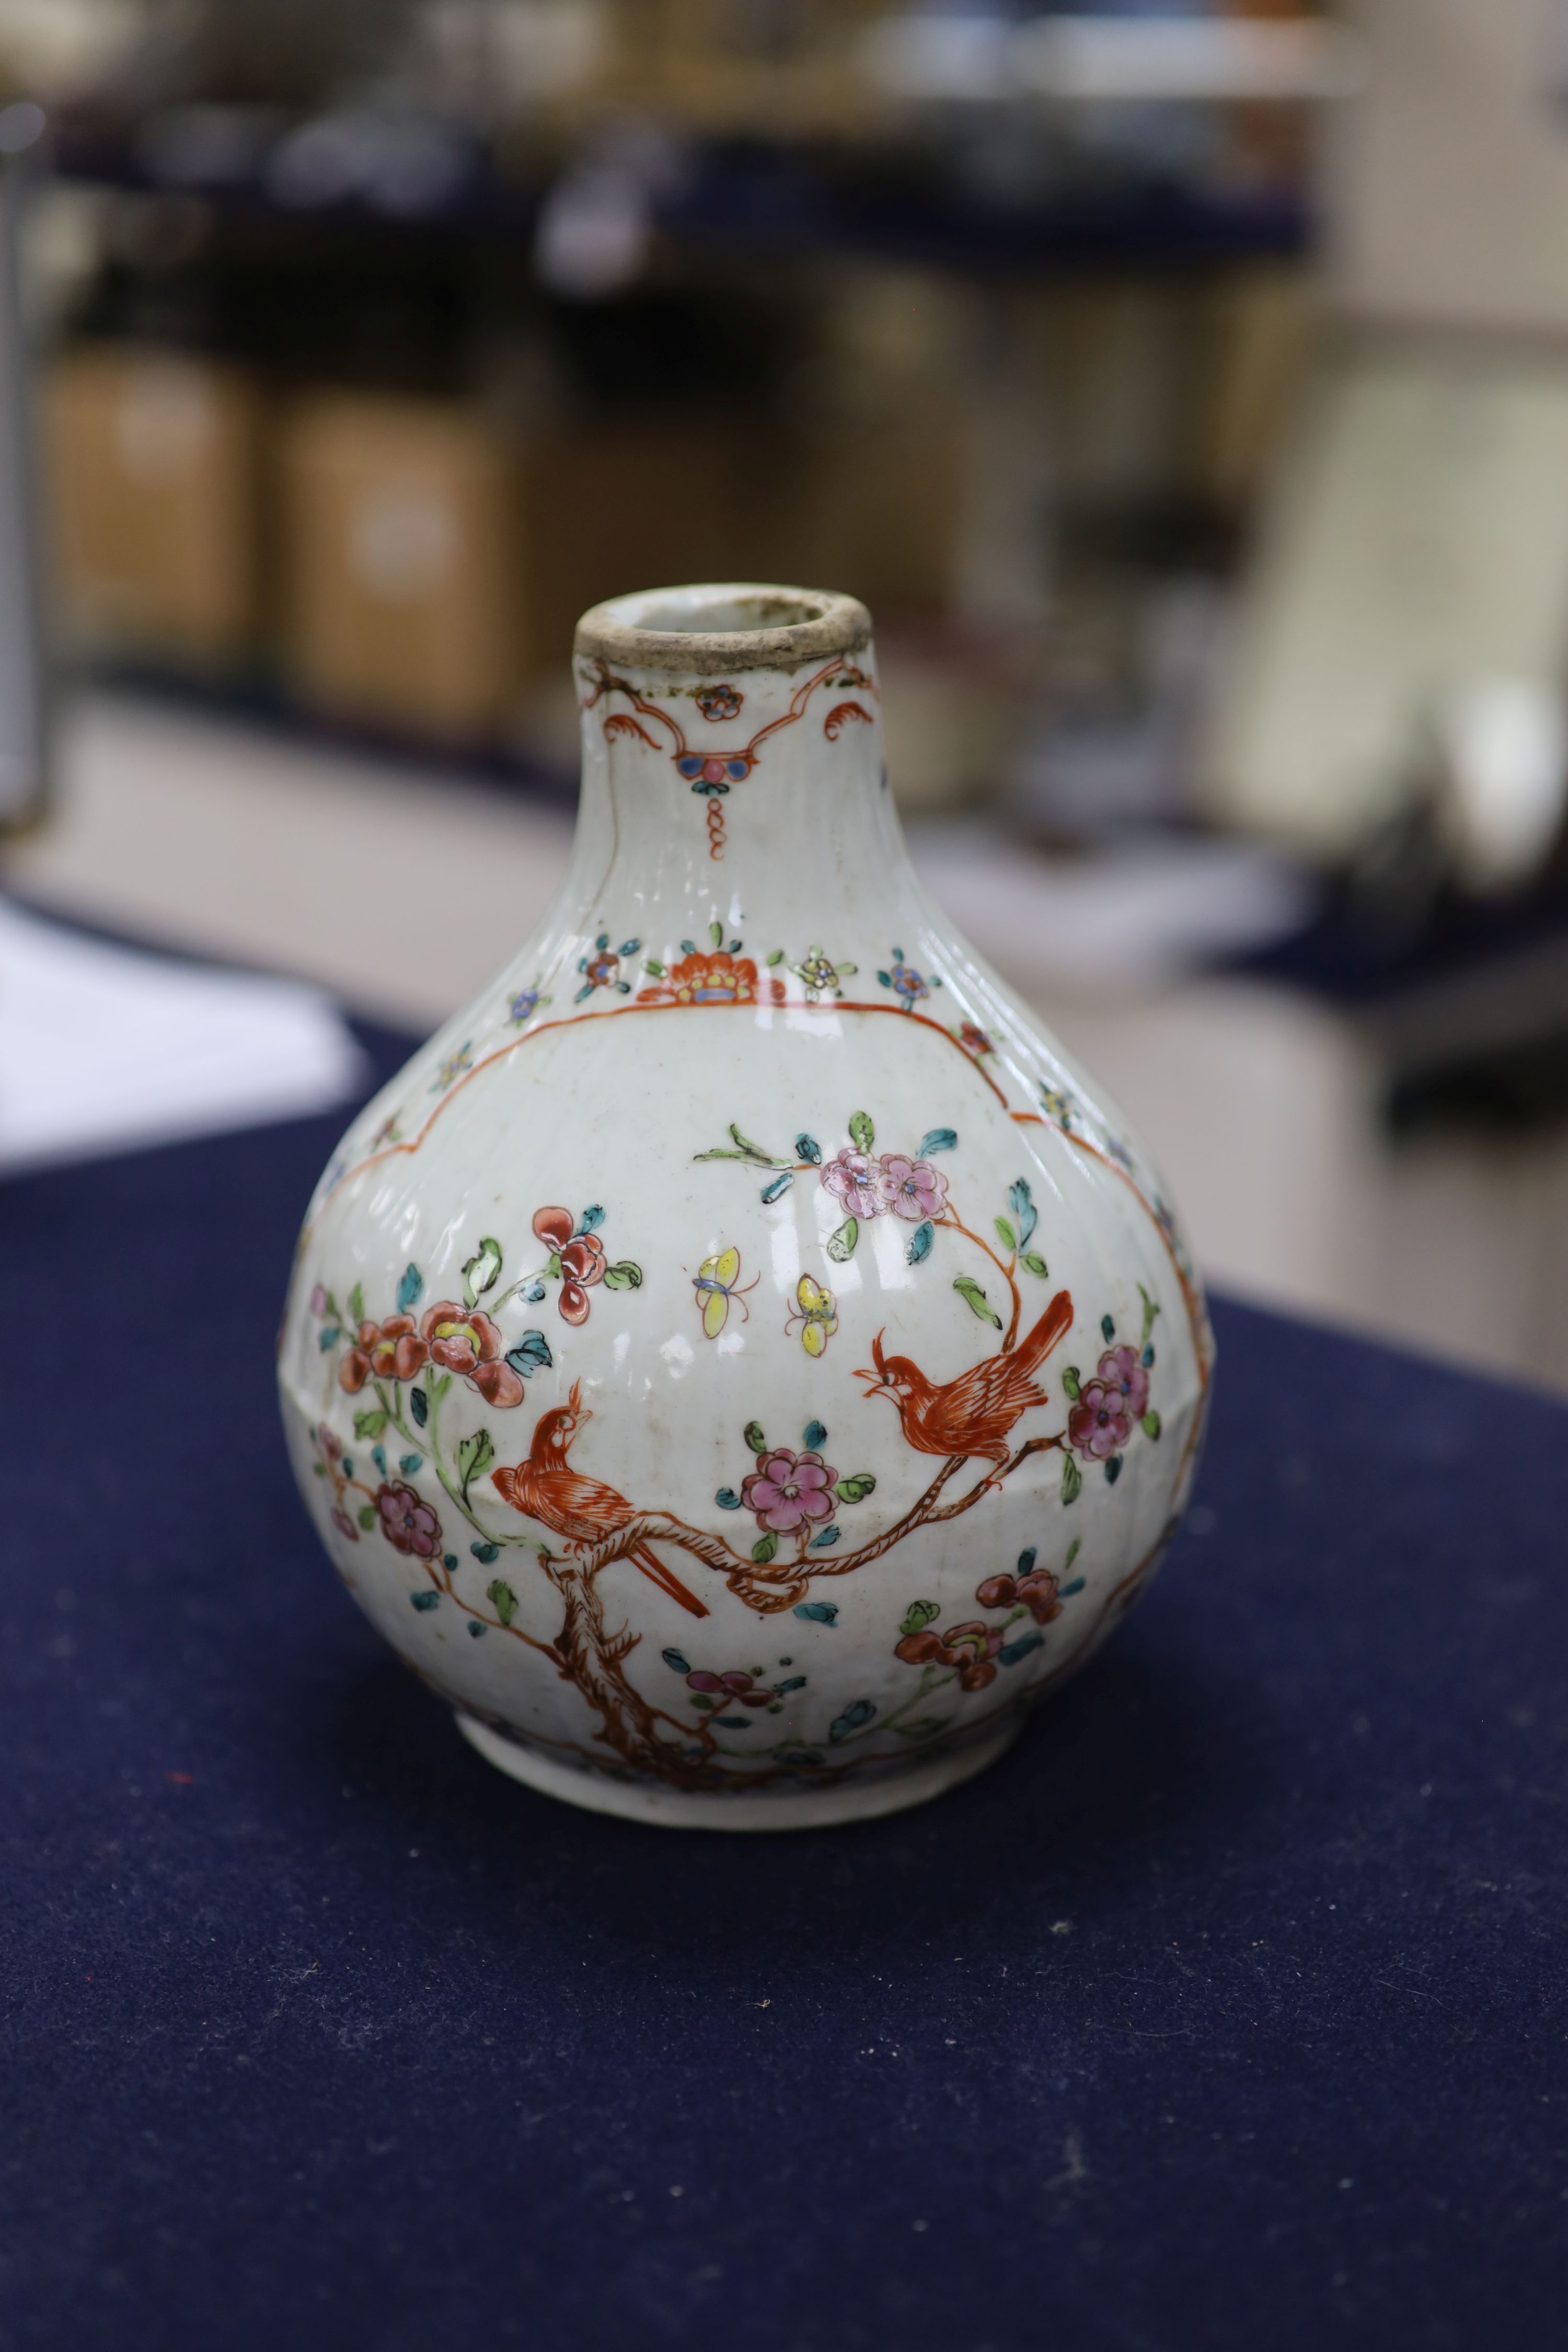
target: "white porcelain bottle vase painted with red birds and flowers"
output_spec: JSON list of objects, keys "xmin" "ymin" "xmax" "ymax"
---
[{"xmin": 280, "ymin": 586, "xmax": 1210, "ymax": 1830}]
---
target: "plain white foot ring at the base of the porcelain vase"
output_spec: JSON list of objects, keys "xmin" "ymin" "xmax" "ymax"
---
[{"xmin": 456, "ymin": 1710, "xmax": 1023, "ymax": 1830}]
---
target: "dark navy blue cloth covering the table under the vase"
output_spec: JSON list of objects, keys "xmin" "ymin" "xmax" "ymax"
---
[{"xmin": 0, "ymin": 1037, "xmax": 1568, "ymax": 2352}]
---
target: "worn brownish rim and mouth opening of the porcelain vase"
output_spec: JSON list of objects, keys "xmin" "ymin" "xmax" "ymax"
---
[{"xmin": 576, "ymin": 581, "xmax": 872, "ymax": 677}]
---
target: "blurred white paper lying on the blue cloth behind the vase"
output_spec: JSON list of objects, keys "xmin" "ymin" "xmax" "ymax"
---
[{"xmin": 0, "ymin": 898, "xmax": 364, "ymax": 1174}]
